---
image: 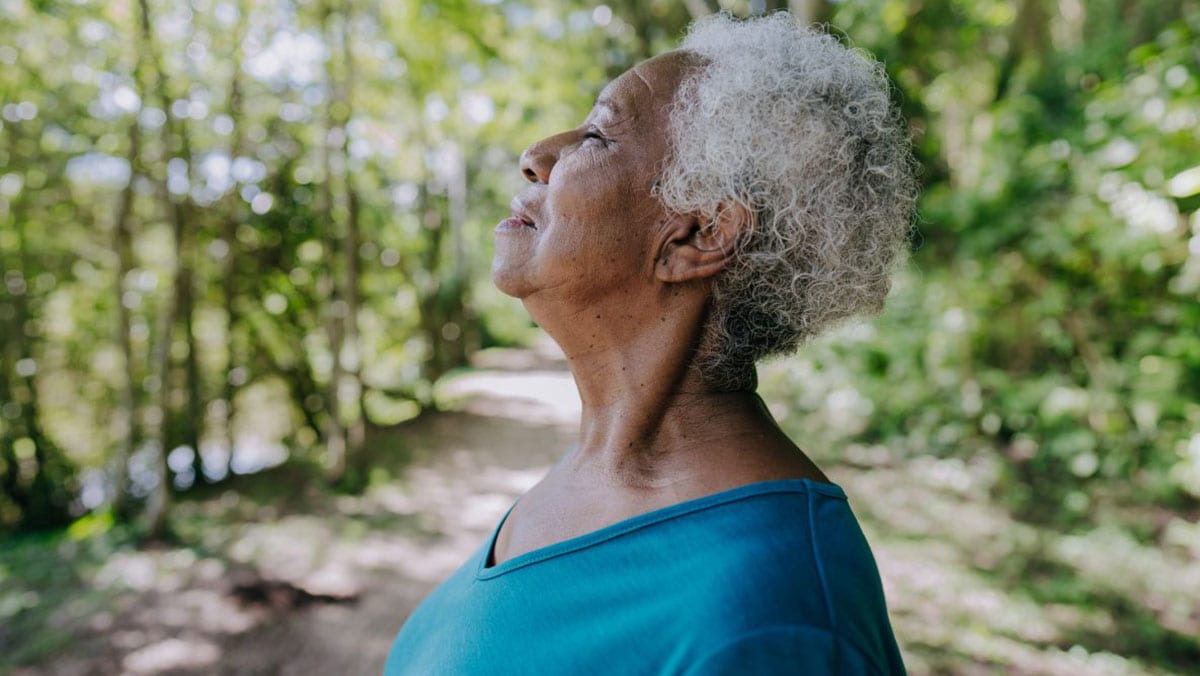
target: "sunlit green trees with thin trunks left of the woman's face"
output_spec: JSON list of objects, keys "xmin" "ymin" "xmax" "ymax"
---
[{"xmin": 0, "ymin": 0, "xmax": 667, "ymax": 531}]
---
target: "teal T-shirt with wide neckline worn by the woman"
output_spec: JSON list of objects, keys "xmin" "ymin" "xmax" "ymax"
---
[{"xmin": 384, "ymin": 480, "xmax": 904, "ymax": 676}]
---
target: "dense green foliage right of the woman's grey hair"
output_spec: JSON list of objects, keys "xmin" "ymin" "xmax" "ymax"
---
[{"xmin": 768, "ymin": 2, "xmax": 1200, "ymax": 524}]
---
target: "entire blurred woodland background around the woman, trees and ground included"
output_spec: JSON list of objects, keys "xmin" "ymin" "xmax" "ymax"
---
[{"xmin": 0, "ymin": 0, "xmax": 1200, "ymax": 674}]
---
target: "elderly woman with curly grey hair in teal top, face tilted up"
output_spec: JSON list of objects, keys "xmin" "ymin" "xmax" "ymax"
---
[{"xmin": 386, "ymin": 13, "xmax": 914, "ymax": 674}]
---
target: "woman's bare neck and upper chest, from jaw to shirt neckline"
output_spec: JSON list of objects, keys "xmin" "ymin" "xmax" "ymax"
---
[{"xmin": 493, "ymin": 285, "xmax": 827, "ymax": 561}]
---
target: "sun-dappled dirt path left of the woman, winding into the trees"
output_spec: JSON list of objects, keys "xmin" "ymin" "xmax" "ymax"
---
[{"xmin": 14, "ymin": 352, "xmax": 577, "ymax": 676}]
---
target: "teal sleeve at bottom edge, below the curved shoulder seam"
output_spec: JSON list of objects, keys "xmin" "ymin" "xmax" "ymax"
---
[{"xmin": 686, "ymin": 626, "xmax": 880, "ymax": 676}]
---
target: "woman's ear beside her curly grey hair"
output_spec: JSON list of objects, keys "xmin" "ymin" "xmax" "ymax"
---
[{"xmin": 654, "ymin": 202, "xmax": 755, "ymax": 282}]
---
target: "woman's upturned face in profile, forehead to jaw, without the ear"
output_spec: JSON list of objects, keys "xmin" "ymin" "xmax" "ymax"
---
[{"xmin": 492, "ymin": 52, "xmax": 689, "ymax": 305}]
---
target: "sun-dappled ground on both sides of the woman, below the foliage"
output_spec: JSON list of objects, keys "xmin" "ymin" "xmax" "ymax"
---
[{"xmin": 0, "ymin": 352, "xmax": 1200, "ymax": 676}]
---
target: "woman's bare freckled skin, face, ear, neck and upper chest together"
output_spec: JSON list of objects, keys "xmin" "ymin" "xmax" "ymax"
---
[{"xmin": 492, "ymin": 52, "xmax": 826, "ymax": 562}]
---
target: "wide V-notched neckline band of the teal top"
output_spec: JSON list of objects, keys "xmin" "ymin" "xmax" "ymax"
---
[{"xmin": 475, "ymin": 479, "xmax": 846, "ymax": 580}]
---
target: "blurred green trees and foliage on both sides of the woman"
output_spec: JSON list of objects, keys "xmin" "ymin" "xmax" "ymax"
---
[{"xmin": 0, "ymin": 0, "xmax": 1200, "ymax": 657}]
